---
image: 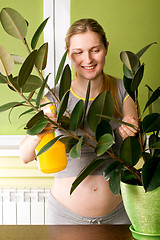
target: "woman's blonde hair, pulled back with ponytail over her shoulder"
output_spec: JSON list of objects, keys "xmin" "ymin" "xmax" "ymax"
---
[{"xmin": 65, "ymin": 18, "xmax": 121, "ymax": 118}]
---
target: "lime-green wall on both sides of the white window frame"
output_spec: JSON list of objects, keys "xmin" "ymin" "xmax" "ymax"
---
[{"xmin": 0, "ymin": 0, "xmax": 160, "ymax": 134}]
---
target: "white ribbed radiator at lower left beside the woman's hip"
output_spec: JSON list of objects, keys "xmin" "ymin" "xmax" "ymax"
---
[{"xmin": 0, "ymin": 188, "xmax": 50, "ymax": 225}]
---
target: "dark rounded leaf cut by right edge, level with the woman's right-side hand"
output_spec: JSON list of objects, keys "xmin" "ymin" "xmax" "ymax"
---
[{"xmin": 142, "ymin": 113, "xmax": 160, "ymax": 133}]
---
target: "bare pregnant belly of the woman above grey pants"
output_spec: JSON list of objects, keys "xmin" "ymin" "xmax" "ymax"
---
[{"xmin": 51, "ymin": 175, "xmax": 122, "ymax": 217}]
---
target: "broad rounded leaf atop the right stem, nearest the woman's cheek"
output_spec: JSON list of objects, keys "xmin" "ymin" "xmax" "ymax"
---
[{"xmin": 120, "ymin": 51, "xmax": 139, "ymax": 74}]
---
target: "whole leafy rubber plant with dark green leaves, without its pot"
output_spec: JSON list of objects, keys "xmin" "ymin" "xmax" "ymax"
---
[{"xmin": 0, "ymin": 8, "xmax": 160, "ymax": 194}]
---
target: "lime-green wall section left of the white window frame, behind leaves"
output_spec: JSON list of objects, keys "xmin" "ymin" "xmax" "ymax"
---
[{"xmin": 0, "ymin": 0, "xmax": 43, "ymax": 135}]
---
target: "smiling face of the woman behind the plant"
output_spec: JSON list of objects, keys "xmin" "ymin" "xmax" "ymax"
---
[{"xmin": 68, "ymin": 31, "xmax": 107, "ymax": 80}]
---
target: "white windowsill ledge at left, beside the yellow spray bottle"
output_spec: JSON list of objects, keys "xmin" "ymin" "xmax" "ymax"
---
[{"xmin": 0, "ymin": 135, "xmax": 25, "ymax": 157}]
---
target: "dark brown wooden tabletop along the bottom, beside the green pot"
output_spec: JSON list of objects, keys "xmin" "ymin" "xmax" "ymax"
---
[{"xmin": 0, "ymin": 225, "xmax": 134, "ymax": 240}]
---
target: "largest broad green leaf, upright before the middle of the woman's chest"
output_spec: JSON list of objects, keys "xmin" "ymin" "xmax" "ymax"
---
[{"xmin": 87, "ymin": 90, "xmax": 114, "ymax": 132}]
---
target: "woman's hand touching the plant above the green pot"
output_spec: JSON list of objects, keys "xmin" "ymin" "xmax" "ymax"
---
[{"xmin": 119, "ymin": 115, "xmax": 138, "ymax": 139}]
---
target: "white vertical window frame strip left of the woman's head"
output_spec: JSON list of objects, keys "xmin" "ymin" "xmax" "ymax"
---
[{"xmin": 43, "ymin": 0, "xmax": 70, "ymax": 87}]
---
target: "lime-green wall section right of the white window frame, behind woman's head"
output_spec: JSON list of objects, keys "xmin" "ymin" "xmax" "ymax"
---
[{"xmin": 71, "ymin": 0, "xmax": 160, "ymax": 109}]
